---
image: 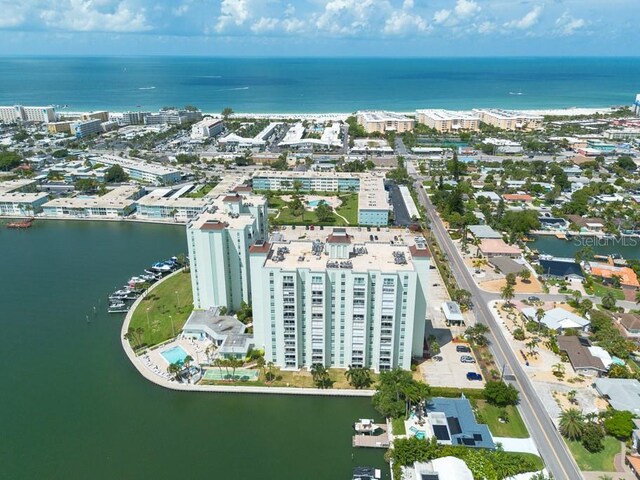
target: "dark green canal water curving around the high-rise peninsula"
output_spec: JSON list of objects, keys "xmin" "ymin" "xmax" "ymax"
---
[{"xmin": 0, "ymin": 221, "xmax": 388, "ymax": 480}]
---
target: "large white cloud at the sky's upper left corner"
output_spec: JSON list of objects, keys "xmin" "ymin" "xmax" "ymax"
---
[{"xmin": 40, "ymin": 0, "xmax": 151, "ymax": 32}]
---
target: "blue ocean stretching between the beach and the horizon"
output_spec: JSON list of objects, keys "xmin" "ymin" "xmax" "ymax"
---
[{"xmin": 0, "ymin": 57, "xmax": 640, "ymax": 113}]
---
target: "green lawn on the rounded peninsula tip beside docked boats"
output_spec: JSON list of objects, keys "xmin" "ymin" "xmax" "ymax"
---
[{"xmin": 130, "ymin": 272, "xmax": 193, "ymax": 346}]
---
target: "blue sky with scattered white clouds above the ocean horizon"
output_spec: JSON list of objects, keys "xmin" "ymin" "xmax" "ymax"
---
[{"xmin": 0, "ymin": 0, "xmax": 640, "ymax": 57}]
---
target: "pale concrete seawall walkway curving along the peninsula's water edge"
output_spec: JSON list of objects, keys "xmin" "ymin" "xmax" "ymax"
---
[{"xmin": 120, "ymin": 270, "xmax": 375, "ymax": 397}]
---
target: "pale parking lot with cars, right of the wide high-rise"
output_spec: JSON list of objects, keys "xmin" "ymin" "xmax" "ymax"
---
[{"xmin": 420, "ymin": 323, "xmax": 484, "ymax": 388}]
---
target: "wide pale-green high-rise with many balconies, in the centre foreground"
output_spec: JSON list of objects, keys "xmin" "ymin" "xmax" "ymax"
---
[{"xmin": 250, "ymin": 228, "xmax": 430, "ymax": 371}]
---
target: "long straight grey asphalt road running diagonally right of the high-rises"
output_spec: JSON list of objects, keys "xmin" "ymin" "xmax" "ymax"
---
[{"xmin": 407, "ymin": 161, "xmax": 583, "ymax": 480}]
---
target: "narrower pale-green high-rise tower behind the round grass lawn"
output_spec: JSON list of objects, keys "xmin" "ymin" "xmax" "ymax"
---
[{"xmin": 187, "ymin": 194, "xmax": 268, "ymax": 310}]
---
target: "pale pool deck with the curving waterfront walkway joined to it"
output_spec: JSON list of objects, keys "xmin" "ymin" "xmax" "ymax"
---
[{"xmin": 120, "ymin": 270, "xmax": 375, "ymax": 398}]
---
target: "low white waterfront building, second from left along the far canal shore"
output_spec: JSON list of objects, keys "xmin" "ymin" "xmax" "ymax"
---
[{"xmin": 42, "ymin": 185, "xmax": 140, "ymax": 219}]
